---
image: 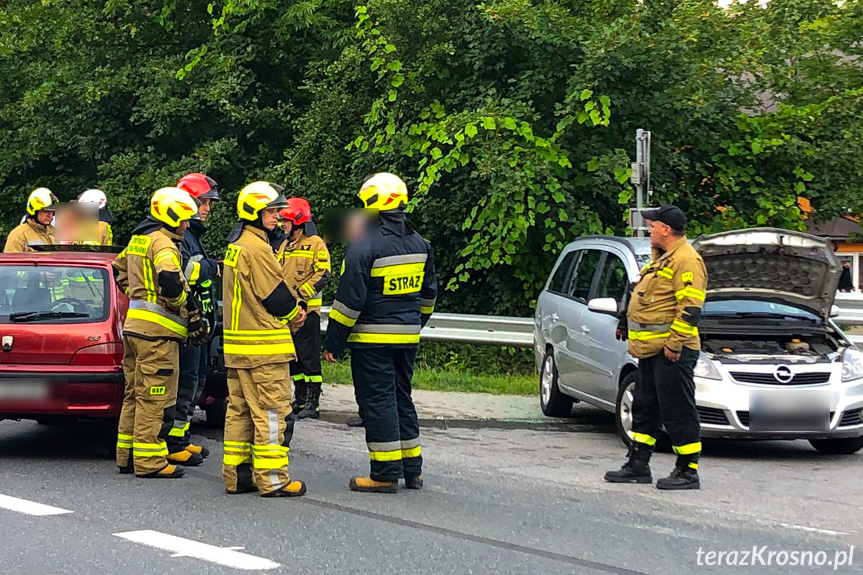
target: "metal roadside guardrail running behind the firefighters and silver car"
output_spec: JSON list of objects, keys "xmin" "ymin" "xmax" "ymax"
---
[{"xmin": 321, "ymin": 293, "xmax": 863, "ymax": 350}]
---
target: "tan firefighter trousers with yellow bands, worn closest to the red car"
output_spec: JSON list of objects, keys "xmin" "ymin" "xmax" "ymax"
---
[{"xmin": 117, "ymin": 336, "xmax": 180, "ymax": 475}]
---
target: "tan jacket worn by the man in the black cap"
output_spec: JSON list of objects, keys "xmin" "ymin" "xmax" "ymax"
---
[{"xmin": 626, "ymin": 237, "xmax": 707, "ymax": 358}]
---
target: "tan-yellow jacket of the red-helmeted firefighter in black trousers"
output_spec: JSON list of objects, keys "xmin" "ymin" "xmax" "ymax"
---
[{"xmin": 278, "ymin": 231, "xmax": 330, "ymax": 312}]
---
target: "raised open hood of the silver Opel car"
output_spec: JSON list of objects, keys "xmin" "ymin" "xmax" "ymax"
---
[{"xmin": 692, "ymin": 228, "xmax": 841, "ymax": 322}]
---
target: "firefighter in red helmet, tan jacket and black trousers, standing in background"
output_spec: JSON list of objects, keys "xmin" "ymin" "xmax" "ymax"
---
[{"xmin": 278, "ymin": 198, "xmax": 330, "ymax": 419}]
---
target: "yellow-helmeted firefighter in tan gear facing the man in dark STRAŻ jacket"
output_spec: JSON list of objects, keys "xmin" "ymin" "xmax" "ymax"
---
[{"xmin": 222, "ymin": 182, "xmax": 306, "ymax": 497}]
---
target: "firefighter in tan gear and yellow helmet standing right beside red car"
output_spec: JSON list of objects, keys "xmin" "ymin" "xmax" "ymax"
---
[{"xmin": 114, "ymin": 188, "xmax": 206, "ymax": 478}]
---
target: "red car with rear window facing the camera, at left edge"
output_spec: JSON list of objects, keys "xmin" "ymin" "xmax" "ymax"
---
[{"xmin": 0, "ymin": 248, "xmax": 128, "ymax": 428}]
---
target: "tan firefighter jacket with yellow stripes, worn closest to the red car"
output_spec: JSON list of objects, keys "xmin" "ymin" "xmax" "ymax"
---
[{"xmin": 113, "ymin": 227, "xmax": 189, "ymax": 342}]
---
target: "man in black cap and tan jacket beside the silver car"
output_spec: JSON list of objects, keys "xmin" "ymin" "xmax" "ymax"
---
[{"xmin": 605, "ymin": 204, "xmax": 707, "ymax": 489}]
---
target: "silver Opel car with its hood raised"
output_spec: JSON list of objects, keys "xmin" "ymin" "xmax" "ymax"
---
[{"xmin": 534, "ymin": 228, "xmax": 863, "ymax": 454}]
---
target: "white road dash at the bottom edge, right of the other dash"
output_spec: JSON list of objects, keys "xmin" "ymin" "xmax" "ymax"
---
[{"xmin": 114, "ymin": 529, "xmax": 281, "ymax": 571}]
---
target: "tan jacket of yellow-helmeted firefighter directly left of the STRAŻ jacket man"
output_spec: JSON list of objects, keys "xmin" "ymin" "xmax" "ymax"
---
[{"xmin": 222, "ymin": 224, "xmax": 300, "ymax": 369}]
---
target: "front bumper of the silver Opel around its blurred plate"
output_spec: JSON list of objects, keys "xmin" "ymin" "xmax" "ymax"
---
[{"xmin": 695, "ymin": 364, "xmax": 863, "ymax": 440}]
